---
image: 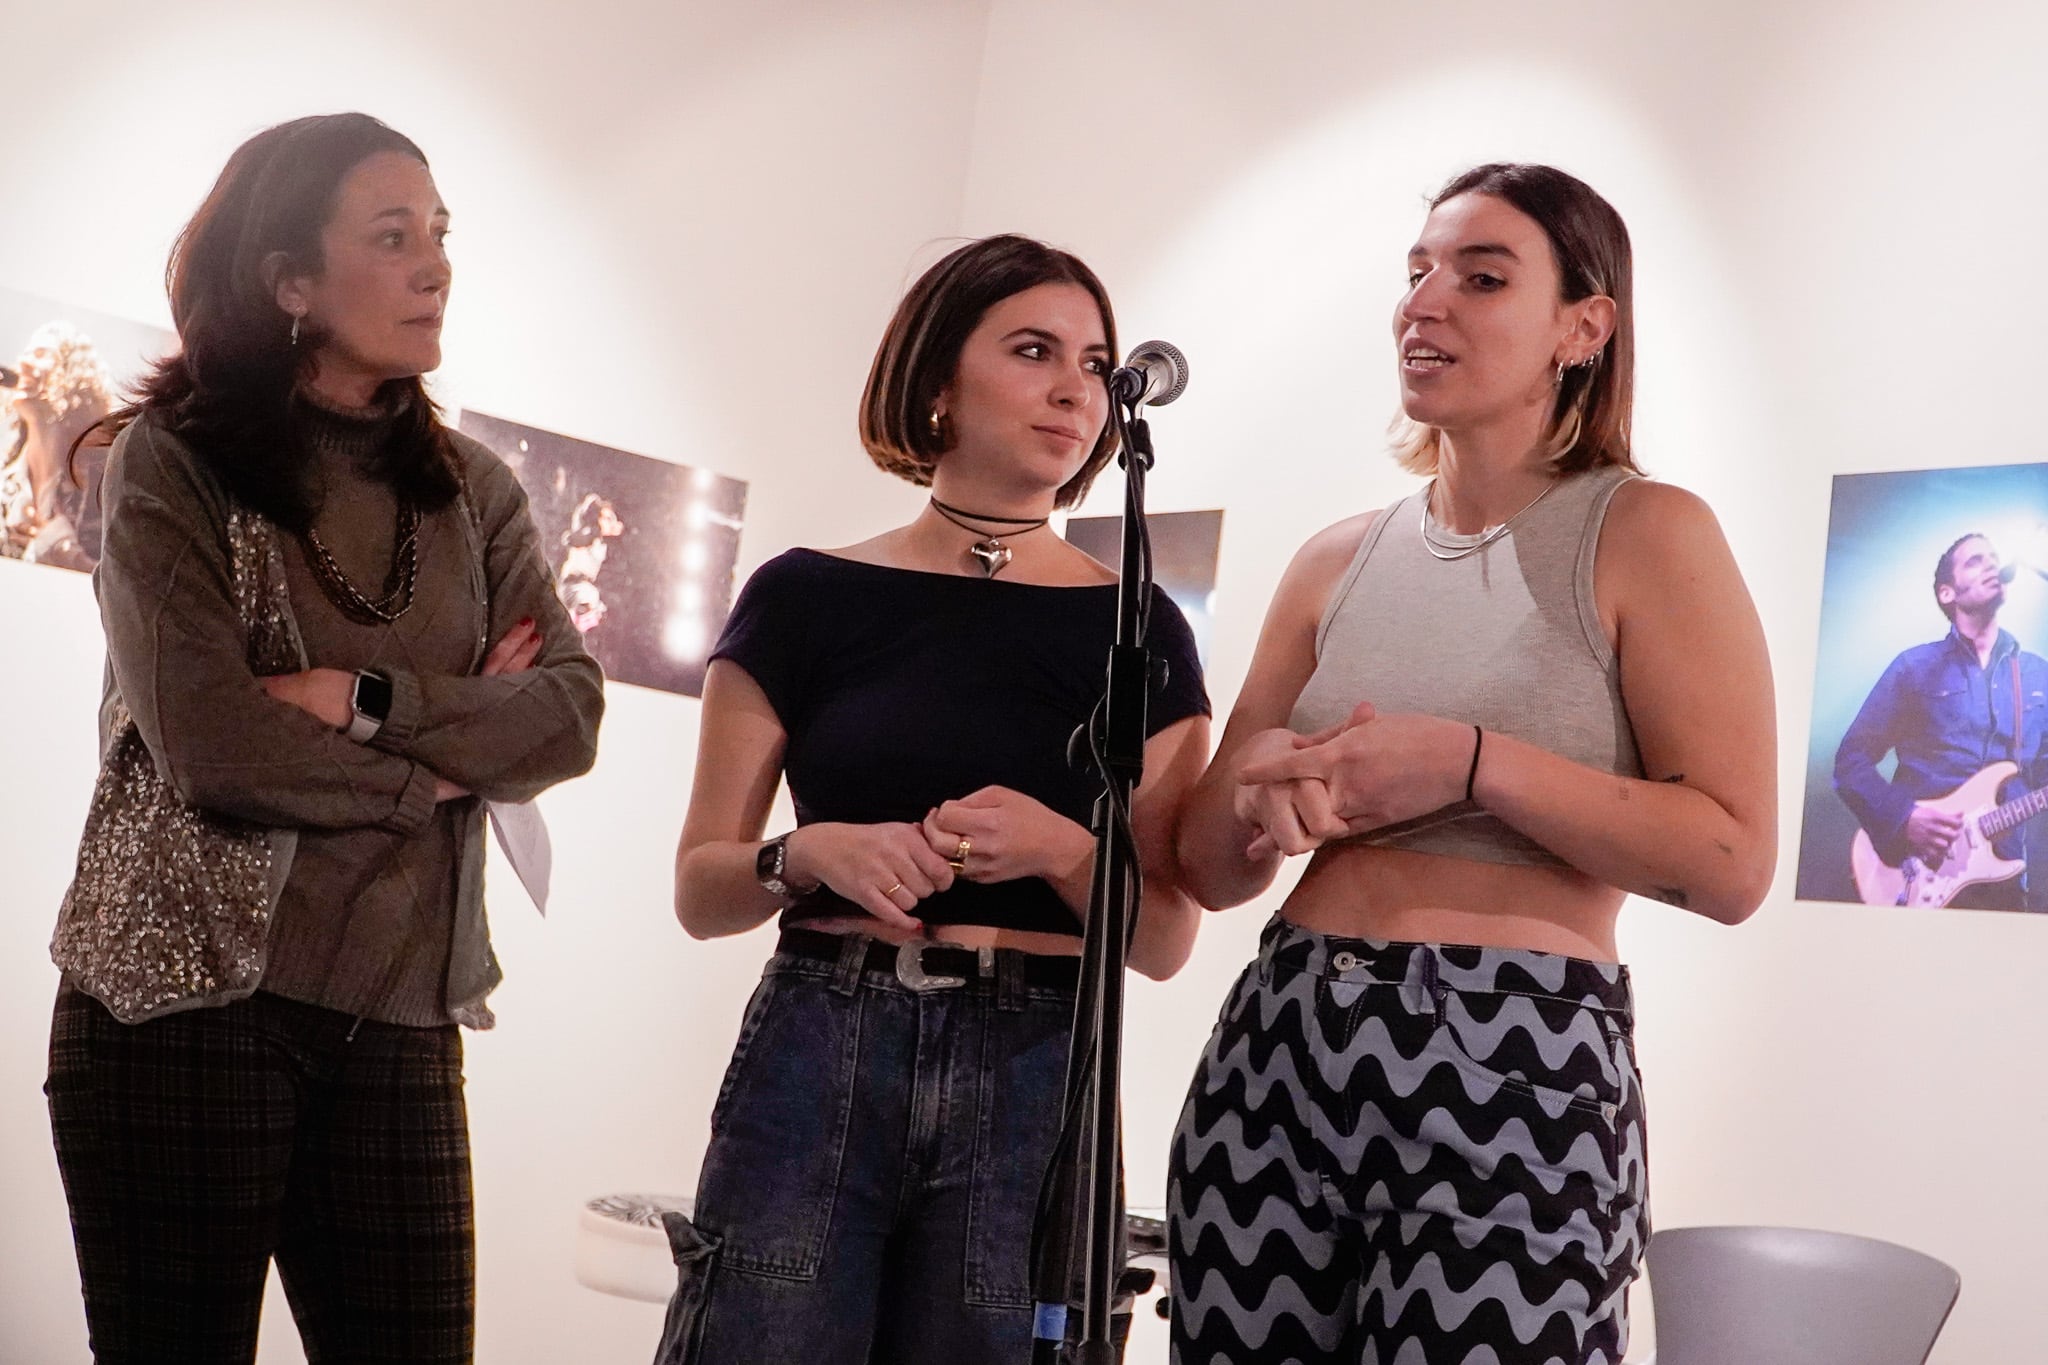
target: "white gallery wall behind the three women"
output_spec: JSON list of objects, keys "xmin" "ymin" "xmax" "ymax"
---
[{"xmin": 0, "ymin": 0, "xmax": 2048, "ymax": 1365}]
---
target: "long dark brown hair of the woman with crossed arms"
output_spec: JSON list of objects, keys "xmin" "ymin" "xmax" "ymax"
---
[{"xmin": 102, "ymin": 113, "xmax": 461, "ymax": 530}]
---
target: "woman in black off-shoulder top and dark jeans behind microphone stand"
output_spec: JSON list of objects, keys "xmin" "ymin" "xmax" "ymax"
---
[{"xmin": 659, "ymin": 237, "xmax": 1208, "ymax": 1365}]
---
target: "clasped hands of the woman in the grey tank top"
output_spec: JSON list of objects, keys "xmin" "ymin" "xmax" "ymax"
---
[{"xmin": 1231, "ymin": 702, "xmax": 1475, "ymax": 862}]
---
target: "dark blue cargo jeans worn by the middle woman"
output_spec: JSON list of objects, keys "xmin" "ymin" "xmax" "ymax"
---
[{"xmin": 657, "ymin": 935, "xmax": 1073, "ymax": 1365}]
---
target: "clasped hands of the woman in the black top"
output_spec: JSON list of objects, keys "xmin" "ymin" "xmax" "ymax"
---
[{"xmin": 786, "ymin": 786, "xmax": 1096, "ymax": 933}]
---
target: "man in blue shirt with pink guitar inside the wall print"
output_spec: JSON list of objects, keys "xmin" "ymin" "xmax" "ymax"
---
[{"xmin": 1835, "ymin": 532, "xmax": 2048, "ymax": 911}]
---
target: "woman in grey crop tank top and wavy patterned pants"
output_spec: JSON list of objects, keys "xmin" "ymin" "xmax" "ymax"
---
[{"xmin": 1167, "ymin": 166, "xmax": 1778, "ymax": 1365}]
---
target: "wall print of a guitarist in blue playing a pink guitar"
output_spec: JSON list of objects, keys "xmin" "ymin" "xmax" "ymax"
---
[{"xmin": 1798, "ymin": 465, "xmax": 2048, "ymax": 911}]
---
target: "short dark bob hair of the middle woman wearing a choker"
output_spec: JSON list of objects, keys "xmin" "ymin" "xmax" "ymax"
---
[{"xmin": 860, "ymin": 233, "xmax": 1118, "ymax": 508}]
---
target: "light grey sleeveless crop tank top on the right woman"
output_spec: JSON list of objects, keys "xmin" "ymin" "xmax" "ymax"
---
[{"xmin": 1288, "ymin": 465, "xmax": 1642, "ymax": 868}]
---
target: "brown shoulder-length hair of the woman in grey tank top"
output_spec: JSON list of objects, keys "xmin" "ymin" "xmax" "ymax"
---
[{"xmin": 1395, "ymin": 162, "xmax": 1640, "ymax": 475}]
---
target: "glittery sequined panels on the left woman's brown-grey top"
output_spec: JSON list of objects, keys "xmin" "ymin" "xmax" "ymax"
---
[{"xmin": 49, "ymin": 508, "xmax": 305, "ymax": 1023}]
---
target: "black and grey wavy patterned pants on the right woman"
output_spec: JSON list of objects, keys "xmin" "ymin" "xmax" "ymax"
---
[{"xmin": 1167, "ymin": 919, "xmax": 1649, "ymax": 1365}]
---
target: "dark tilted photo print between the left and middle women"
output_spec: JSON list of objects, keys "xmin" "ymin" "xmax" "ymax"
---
[{"xmin": 457, "ymin": 411, "xmax": 748, "ymax": 696}]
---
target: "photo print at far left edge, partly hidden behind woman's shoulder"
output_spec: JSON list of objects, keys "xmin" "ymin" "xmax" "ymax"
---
[{"xmin": 0, "ymin": 289, "xmax": 178, "ymax": 573}]
